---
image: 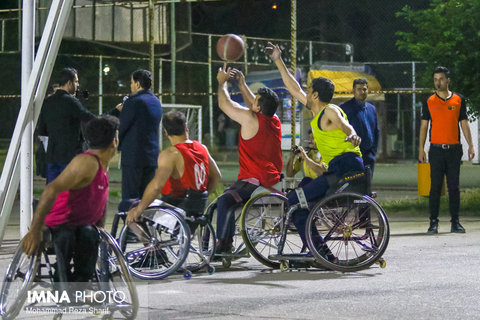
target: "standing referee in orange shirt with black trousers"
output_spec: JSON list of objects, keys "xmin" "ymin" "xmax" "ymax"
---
[{"xmin": 418, "ymin": 67, "xmax": 475, "ymax": 234}]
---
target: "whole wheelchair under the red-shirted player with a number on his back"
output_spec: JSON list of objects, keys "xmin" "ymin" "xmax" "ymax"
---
[{"xmin": 112, "ymin": 199, "xmax": 215, "ymax": 280}]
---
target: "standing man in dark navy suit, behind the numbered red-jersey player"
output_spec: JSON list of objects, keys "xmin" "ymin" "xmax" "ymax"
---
[{"xmin": 119, "ymin": 69, "xmax": 162, "ymax": 202}]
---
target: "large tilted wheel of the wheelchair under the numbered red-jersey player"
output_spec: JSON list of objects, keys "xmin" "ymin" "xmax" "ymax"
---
[{"xmin": 119, "ymin": 207, "xmax": 190, "ymax": 280}]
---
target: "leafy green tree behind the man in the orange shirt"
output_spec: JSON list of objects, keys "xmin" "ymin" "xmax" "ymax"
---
[{"xmin": 397, "ymin": 0, "xmax": 480, "ymax": 116}]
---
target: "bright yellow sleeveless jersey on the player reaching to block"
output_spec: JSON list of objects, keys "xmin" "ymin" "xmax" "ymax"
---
[{"xmin": 310, "ymin": 107, "xmax": 362, "ymax": 165}]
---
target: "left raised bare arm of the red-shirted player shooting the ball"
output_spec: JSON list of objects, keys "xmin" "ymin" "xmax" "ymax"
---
[{"xmin": 217, "ymin": 63, "xmax": 258, "ymax": 126}]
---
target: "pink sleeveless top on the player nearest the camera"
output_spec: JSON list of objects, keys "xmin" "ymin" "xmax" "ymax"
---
[{"xmin": 45, "ymin": 151, "xmax": 108, "ymax": 227}]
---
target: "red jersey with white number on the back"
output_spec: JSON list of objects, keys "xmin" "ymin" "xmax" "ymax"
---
[{"xmin": 162, "ymin": 140, "xmax": 209, "ymax": 197}]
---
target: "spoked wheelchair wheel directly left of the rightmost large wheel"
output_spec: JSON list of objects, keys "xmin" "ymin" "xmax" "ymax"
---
[{"xmin": 241, "ymin": 193, "xmax": 302, "ymax": 269}]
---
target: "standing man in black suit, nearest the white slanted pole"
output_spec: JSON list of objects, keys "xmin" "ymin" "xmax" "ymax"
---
[{"xmin": 38, "ymin": 68, "xmax": 95, "ymax": 183}]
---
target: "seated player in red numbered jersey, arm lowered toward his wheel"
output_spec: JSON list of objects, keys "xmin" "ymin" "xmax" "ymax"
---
[{"xmin": 127, "ymin": 111, "xmax": 221, "ymax": 225}]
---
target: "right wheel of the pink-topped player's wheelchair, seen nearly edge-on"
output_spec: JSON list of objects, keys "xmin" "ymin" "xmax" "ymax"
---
[{"xmin": 96, "ymin": 228, "xmax": 139, "ymax": 319}]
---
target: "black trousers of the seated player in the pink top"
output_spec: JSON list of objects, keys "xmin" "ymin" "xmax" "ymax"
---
[{"xmin": 50, "ymin": 225, "xmax": 100, "ymax": 282}]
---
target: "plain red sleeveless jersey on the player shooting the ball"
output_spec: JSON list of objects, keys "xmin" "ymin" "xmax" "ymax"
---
[{"xmin": 238, "ymin": 113, "xmax": 283, "ymax": 188}]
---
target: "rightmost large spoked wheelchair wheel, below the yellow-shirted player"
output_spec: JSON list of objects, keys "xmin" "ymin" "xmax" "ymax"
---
[{"xmin": 306, "ymin": 193, "xmax": 390, "ymax": 272}]
